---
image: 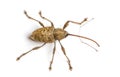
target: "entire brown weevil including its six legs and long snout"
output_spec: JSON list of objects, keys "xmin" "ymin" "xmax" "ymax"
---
[{"xmin": 16, "ymin": 11, "xmax": 100, "ymax": 70}]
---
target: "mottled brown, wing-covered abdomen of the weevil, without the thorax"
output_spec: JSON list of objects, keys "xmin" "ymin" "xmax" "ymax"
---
[{"xmin": 32, "ymin": 27, "xmax": 55, "ymax": 43}]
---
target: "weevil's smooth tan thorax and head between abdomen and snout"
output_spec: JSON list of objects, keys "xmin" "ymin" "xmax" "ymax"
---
[{"xmin": 54, "ymin": 28, "xmax": 68, "ymax": 40}]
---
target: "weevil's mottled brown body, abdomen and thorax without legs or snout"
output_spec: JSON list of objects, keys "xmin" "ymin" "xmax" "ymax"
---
[{"xmin": 30, "ymin": 27, "xmax": 68, "ymax": 43}]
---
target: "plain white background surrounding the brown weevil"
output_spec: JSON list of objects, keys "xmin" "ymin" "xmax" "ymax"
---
[{"xmin": 0, "ymin": 0, "xmax": 120, "ymax": 77}]
